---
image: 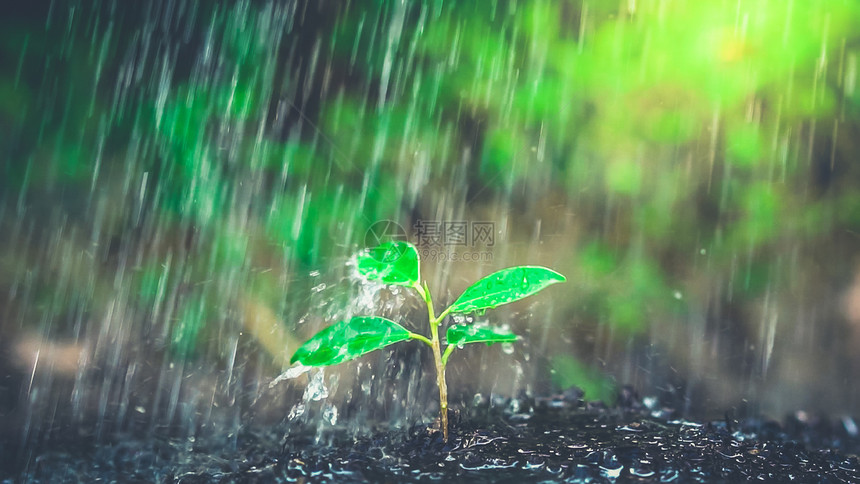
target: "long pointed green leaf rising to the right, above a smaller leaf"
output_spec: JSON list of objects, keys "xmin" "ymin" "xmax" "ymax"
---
[{"xmin": 449, "ymin": 266, "xmax": 565, "ymax": 313}]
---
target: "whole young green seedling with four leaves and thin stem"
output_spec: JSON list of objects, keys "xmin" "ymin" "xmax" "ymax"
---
[{"xmin": 290, "ymin": 241, "xmax": 565, "ymax": 441}]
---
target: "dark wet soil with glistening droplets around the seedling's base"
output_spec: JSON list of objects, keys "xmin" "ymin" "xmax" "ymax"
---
[{"xmin": 4, "ymin": 393, "xmax": 860, "ymax": 483}]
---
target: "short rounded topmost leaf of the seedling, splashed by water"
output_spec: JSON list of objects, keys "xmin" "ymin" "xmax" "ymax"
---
[{"xmin": 358, "ymin": 241, "xmax": 420, "ymax": 286}]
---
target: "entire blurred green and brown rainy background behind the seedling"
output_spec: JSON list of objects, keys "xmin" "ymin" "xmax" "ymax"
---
[{"xmin": 0, "ymin": 0, "xmax": 860, "ymax": 434}]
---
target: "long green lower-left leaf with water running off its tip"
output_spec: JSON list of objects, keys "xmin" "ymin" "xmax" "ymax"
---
[{"xmin": 290, "ymin": 316, "xmax": 410, "ymax": 366}]
